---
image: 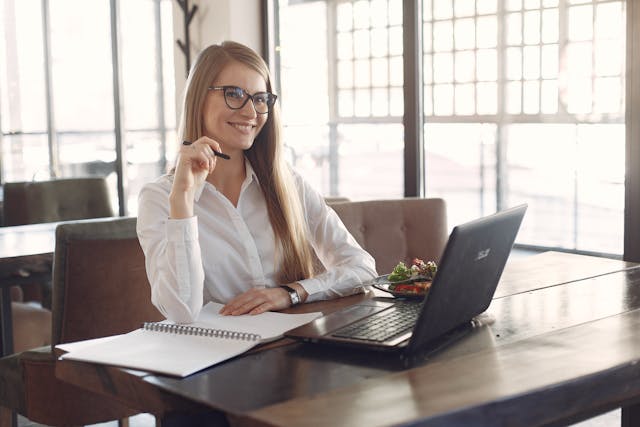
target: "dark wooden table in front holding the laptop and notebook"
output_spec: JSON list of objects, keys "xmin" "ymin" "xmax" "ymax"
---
[{"xmin": 56, "ymin": 252, "xmax": 640, "ymax": 426}]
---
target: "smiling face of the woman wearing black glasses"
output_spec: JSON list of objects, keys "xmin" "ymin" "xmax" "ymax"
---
[{"xmin": 202, "ymin": 61, "xmax": 269, "ymax": 153}]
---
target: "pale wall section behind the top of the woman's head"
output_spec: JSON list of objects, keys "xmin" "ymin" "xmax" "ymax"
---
[{"xmin": 173, "ymin": 0, "xmax": 262, "ymax": 120}]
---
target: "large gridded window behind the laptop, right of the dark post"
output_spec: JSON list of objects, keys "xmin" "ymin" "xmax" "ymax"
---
[{"xmin": 423, "ymin": 0, "xmax": 625, "ymax": 254}]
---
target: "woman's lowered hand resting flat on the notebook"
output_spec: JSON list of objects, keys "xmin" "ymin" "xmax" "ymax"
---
[{"xmin": 220, "ymin": 287, "xmax": 291, "ymax": 316}]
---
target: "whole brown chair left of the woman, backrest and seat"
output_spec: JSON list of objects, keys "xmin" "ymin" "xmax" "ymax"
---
[{"xmin": 0, "ymin": 218, "xmax": 163, "ymax": 426}]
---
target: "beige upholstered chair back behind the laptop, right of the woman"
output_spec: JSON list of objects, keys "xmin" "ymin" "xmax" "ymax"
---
[{"xmin": 330, "ymin": 198, "xmax": 448, "ymax": 274}]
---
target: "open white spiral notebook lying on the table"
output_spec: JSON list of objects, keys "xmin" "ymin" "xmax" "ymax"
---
[{"xmin": 56, "ymin": 303, "xmax": 322, "ymax": 377}]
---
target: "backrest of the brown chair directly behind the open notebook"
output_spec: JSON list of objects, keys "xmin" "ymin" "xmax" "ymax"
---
[{"xmin": 52, "ymin": 218, "xmax": 163, "ymax": 346}]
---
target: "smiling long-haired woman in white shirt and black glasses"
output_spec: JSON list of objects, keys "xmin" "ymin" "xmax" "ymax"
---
[{"xmin": 138, "ymin": 42, "xmax": 376, "ymax": 323}]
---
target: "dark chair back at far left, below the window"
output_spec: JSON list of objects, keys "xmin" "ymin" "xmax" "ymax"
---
[{"xmin": 3, "ymin": 177, "xmax": 115, "ymax": 225}]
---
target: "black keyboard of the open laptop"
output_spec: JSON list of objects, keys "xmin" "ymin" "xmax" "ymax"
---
[{"xmin": 331, "ymin": 303, "xmax": 422, "ymax": 342}]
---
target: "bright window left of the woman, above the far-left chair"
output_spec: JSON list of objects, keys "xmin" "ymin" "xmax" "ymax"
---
[{"xmin": 0, "ymin": 0, "xmax": 175, "ymax": 215}]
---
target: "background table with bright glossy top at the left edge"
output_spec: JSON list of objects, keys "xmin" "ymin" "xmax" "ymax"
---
[{"xmin": 0, "ymin": 222, "xmax": 60, "ymax": 357}]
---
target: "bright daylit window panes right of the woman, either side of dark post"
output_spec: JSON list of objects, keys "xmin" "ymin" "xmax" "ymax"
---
[{"xmin": 278, "ymin": 0, "xmax": 626, "ymax": 254}]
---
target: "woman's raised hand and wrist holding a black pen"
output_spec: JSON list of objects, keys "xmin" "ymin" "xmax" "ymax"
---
[{"xmin": 169, "ymin": 136, "xmax": 221, "ymax": 219}]
